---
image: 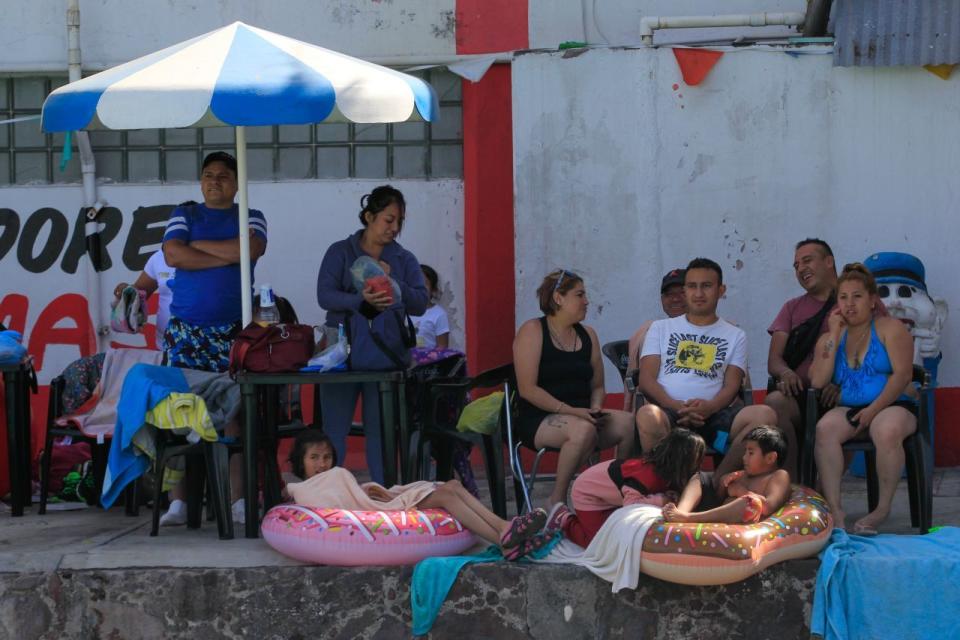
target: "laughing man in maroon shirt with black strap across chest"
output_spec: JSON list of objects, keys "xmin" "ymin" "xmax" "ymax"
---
[{"xmin": 764, "ymin": 238, "xmax": 887, "ymax": 477}]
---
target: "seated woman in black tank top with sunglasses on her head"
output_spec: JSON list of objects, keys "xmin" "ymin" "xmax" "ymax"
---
[{"xmin": 513, "ymin": 270, "xmax": 635, "ymax": 505}]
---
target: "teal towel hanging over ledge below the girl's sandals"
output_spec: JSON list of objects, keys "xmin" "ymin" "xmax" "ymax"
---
[{"xmin": 410, "ymin": 535, "xmax": 563, "ymax": 636}]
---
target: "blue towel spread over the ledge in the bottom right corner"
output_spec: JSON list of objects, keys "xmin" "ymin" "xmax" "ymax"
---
[{"xmin": 810, "ymin": 527, "xmax": 960, "ymax": 640}]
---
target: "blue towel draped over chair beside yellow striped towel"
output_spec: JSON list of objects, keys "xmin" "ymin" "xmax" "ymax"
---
[{"xmin": 100, "ymin": 364, "xmax": 190, "ymax": 509}]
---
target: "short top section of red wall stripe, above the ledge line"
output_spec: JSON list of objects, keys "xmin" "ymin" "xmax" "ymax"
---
[{"xmin": 456, "ymin": 0, "xmax": 530, "ymax": 54}]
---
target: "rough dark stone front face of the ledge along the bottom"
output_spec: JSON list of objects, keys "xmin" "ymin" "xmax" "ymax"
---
[{"xmin": 0, "ymin": 560, "xmax": 817, "ymax": 640}]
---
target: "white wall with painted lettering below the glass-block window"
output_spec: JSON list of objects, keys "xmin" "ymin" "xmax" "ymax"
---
[{"xmin": 0, "ymin": 180, "xmax": 464, "ymax": 383}]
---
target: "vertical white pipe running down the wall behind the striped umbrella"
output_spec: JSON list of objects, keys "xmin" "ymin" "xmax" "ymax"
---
[{"xmin": 67, "ymin": 0, "xmax": 106, "ymax": 352}]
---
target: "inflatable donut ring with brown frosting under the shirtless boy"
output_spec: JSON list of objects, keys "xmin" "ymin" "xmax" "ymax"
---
[{"xmin": 640, "ymin": 485, "xmax": 833, "ymax": 585}]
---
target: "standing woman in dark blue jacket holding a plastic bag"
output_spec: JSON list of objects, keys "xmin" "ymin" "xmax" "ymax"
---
[{"xmin": 317, "ymin": 185, "xmax": 430, "ymax": 483}]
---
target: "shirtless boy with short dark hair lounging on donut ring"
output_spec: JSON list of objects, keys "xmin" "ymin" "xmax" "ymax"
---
[{"xmin": 663, "ymin": 425, "xmax": 790, "ymax": 524}]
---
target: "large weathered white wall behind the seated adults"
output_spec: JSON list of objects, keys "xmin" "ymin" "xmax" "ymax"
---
[{"xmin": 513, "ymin": 49, "xmax": 960, "ymax": 390}]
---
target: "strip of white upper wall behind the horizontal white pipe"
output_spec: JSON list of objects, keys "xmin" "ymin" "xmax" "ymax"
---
[{"xmin": 528, "ymin": 0, "xmax": 807, "ymax": 49}]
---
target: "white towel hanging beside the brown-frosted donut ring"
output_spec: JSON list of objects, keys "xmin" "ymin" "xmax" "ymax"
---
[{"xmin": 533, "ymin": 504, "xmax": 661, "ymax": 593}]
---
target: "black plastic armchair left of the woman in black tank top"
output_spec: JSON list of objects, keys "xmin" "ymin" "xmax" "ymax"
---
[{"xmin": 409, "ymin": 364, "xmax": 513, "ymax": 518}]
